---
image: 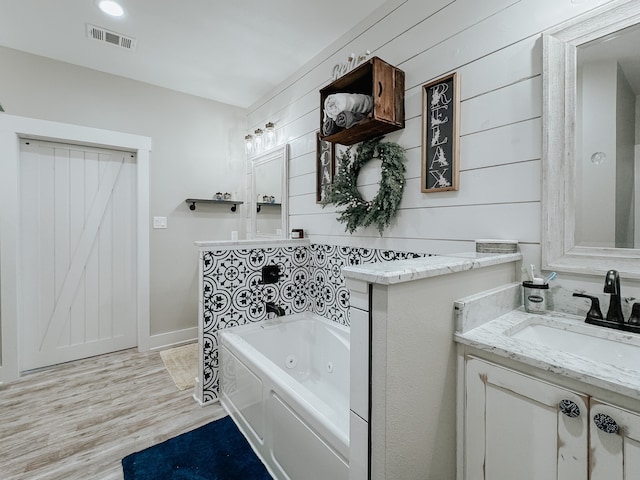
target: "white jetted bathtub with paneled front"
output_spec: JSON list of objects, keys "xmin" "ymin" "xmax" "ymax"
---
[{"xmin": 219, "ymin": 313, "xmax": 349, "ymax": 480}]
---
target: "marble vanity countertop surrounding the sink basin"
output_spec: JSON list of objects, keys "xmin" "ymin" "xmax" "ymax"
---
[{"xmin": 454, "ymin": 309, "xmax": 640, "ymax": 400}]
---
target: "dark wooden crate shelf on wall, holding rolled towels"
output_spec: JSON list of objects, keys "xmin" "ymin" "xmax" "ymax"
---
[{"xmin": 320, "ymin": 57, "xmax": 404, "ymax": 145}]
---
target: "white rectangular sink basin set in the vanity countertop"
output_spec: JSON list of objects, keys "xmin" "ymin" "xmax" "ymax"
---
[{"xmin": 505, "ymin": 317, "xmax": 640, "ymax": 371}]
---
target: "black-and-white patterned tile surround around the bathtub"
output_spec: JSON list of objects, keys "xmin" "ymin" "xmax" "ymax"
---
[{"xmin": 195, "ymin": 239, "xmax": 427, "ymax": 403}]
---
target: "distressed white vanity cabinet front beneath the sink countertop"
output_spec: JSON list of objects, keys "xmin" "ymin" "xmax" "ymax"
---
[{"xmin": 462, "ymin": 356, "xmax": 640, "ymax": 480}]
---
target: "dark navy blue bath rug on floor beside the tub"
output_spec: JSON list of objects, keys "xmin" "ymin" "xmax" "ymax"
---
[{"xmin": 122, "ymin": 416, "xmax": 271, "ymax": 480}]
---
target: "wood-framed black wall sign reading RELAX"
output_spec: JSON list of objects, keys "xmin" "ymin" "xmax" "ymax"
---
[{"xmin": 421, "ymin": 73, "xmax": 460, "ymax": 193}]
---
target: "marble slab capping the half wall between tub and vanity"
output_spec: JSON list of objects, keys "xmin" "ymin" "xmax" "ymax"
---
[{"xmin": 342, "ymin": 252, "xmax": 522, "ymax": 285}]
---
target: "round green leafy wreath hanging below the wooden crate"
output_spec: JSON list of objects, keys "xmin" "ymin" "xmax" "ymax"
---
[{"xmin": 322, "ymin": 138, "xmax": 406, "ymax": 235}]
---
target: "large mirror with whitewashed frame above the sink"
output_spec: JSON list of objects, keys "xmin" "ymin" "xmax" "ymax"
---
[{"xmin": 542, "ymin": 0, "xmax": 640, "ymax": 278}]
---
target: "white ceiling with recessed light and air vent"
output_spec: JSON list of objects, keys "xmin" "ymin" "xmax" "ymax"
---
[{"xmin": 0, "ymin": 0, "xmax": 385, "ymax": 107}]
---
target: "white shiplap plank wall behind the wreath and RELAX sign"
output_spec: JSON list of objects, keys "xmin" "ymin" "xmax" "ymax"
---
[{"xmin": 248, "ymin": 0, "xmax": 608, "ymax": 265}]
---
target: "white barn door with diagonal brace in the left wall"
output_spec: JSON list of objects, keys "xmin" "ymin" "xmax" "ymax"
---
[{"xmin": 19, "ymin": 140, "xmax": 137, "ymax": 371}]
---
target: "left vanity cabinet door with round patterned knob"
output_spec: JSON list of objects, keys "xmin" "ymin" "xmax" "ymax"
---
[{"xmin": 464, "ymin": 357, "xmax": 588, "ymax": 480}]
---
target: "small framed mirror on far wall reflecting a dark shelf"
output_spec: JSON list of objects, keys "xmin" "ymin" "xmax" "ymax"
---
[{"xmin": 248, "ymin": 145, "xmax": 289, "ymax": 238}]
